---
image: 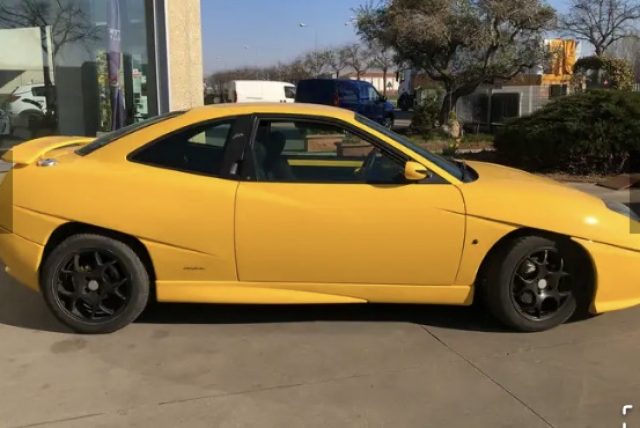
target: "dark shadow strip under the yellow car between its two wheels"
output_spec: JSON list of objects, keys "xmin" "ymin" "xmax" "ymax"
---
[{"xmin": 137, "ymin": 303, "xmax": 510, "ymax": 332}]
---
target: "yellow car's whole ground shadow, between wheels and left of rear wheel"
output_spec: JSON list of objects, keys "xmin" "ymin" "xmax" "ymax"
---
[{"xmin": 0, "ymin": 265, "xmax": 548, "ymax": 333}]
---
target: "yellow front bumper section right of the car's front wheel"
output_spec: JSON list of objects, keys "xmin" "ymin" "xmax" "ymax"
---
[{"xmin": 574, "ymin": 239, "xmax": 640, "ymax": 314}]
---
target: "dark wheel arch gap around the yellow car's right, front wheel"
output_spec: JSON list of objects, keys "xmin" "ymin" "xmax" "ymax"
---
[{"xmin": 474, "ymin": 228, "xmax": 597, "ymax": 309}]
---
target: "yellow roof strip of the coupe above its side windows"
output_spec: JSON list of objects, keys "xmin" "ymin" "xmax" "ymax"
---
[{"xmin": 185, "ymin": 103, "xmax": 355, "ymax": 120}]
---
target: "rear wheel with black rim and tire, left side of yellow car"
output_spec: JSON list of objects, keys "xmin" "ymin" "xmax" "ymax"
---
[{"xmin": 40, "ymin": 234, "xmax": 150, "ymax": 334}]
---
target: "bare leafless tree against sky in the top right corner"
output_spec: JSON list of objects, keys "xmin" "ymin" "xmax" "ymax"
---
[{"xmin": 559, "ymin": 0, "xmax": 640, "ymax": 56}]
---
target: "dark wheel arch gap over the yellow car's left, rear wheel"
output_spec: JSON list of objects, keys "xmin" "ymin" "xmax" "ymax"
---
[{"xmin": 38, "ymin": 222, "xmax": 156, "ymax": 298}]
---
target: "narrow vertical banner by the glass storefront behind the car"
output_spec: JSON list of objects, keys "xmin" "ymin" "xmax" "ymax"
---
[{"xmin": 107, "ymin": 0, "xmax": 126, "ymax": 130}]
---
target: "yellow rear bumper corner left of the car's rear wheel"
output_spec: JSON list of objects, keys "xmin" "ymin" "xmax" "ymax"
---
[{"xmin": 0, "ymin": 229, "xmax": 43, "ymax": 290}]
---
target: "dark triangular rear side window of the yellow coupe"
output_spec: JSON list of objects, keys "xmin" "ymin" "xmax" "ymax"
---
[{"xmin": 130, "ymin": 120, "xmax": 234, "ymax": 176}]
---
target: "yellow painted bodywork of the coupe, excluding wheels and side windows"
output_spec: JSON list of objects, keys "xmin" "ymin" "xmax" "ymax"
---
[{"xmin": 0, "ymin": 104, "xmax": 640, "ymax": 312}]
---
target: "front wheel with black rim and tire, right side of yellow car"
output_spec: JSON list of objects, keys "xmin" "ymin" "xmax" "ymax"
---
[{"xmin": 482, "ymin": 236, "xmax": 586, "ymax": 332}]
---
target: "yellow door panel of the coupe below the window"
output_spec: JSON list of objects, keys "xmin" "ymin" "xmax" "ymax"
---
[{"xmin": 236, "ymin": 183, "xmax": 465, "ymax": 285}]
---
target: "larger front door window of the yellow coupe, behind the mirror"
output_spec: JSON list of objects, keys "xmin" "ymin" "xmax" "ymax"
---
[{"xmin": 253, "ymin": 120, "xmax": 404, "ymax": 184}]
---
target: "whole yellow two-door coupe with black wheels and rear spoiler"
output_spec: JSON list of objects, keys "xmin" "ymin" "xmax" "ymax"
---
[{"xmin": 0, "ymin": 104, "xmax": 640, "ymax": 333}]
